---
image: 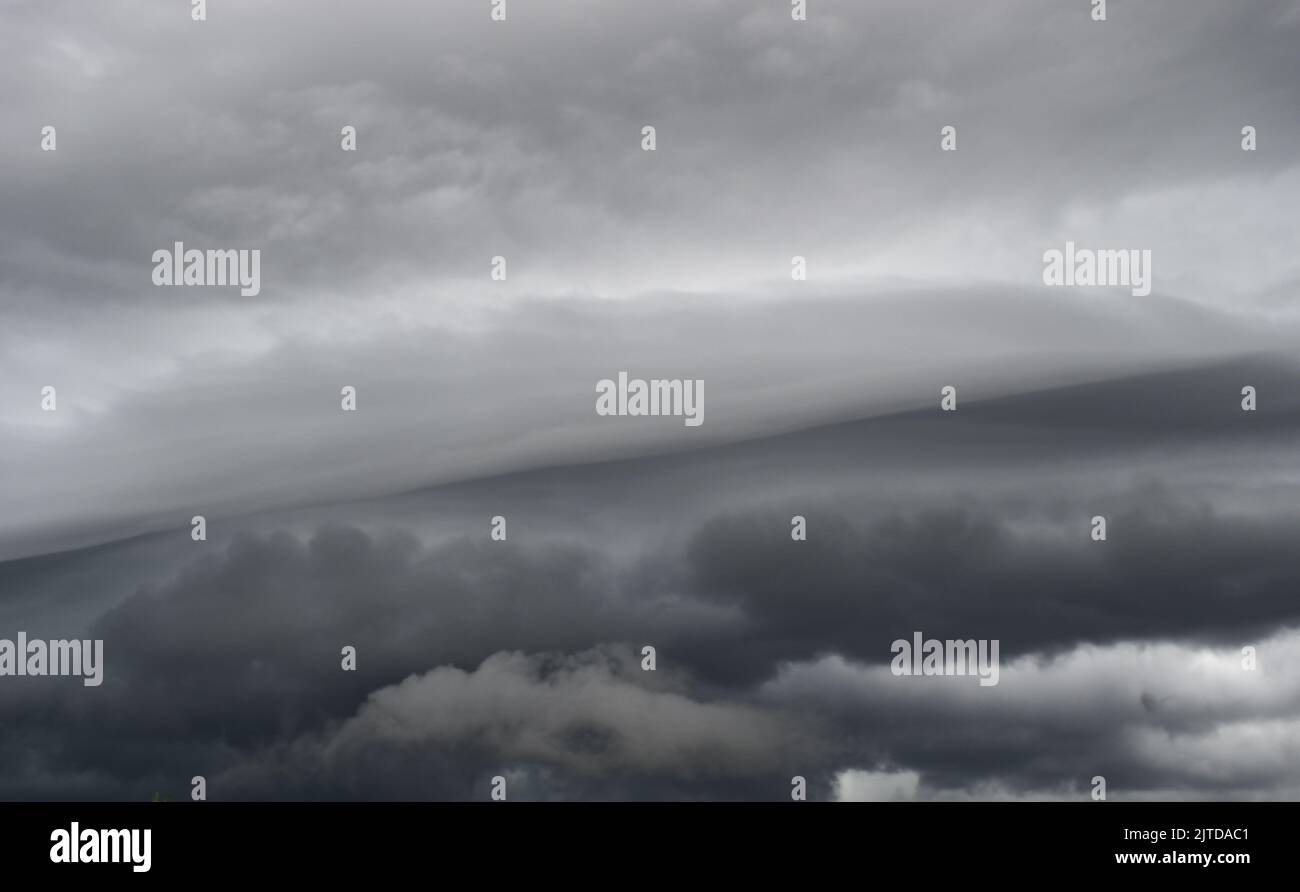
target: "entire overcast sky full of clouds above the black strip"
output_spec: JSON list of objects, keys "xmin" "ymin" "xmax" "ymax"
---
[{"xmin": 0, "ymin": 0, "xmax": 1300, "ymax": 800}]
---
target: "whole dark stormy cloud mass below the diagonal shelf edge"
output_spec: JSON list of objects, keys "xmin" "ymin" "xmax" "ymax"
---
[{"xmin": 4, "ymin": 353, "xmax": 1300, "ymax": 798}]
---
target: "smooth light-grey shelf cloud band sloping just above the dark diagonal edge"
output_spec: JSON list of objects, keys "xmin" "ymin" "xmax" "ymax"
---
[{"xmin": 0, "ymin": 291, "xmax": 1294, "ymax": 557}]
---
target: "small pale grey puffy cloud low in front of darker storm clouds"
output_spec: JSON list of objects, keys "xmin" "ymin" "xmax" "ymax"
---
[{"xmin": 326, "ymin": 648, "xmax": 816, "ymax": 785}]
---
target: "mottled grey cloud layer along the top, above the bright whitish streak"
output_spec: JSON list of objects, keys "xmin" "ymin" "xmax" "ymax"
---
[{"xmin": 0, "ymin": 0, "xmax": 1297, "ymax": 303}]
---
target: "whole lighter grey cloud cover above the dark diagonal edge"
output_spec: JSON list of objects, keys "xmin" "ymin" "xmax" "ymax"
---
[{"xmin": 0, "ymin": 1, "xmax": 1300, "ymax": 557}]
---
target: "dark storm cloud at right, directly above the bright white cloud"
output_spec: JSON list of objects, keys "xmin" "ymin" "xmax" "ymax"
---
[{"xmin": 676, "ymin": 490, "xmax": 1300, "ymax": 679}]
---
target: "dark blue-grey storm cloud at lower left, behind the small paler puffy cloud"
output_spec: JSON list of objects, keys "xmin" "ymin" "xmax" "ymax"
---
[{"xmin": 4, "ymin": 529, "xmax": 766, "ymax": 796}]
